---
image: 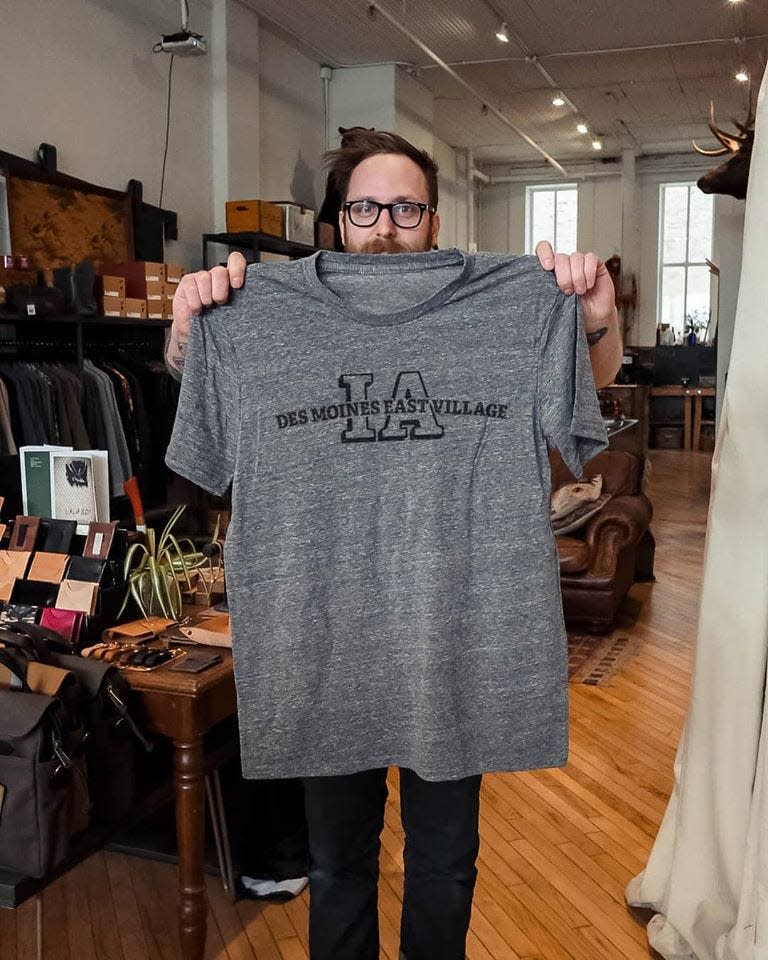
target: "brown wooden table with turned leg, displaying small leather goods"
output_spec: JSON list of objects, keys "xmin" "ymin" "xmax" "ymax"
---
[{"xmin": 123, "ymin": 647, "xmax": 237, "ymax": 960}]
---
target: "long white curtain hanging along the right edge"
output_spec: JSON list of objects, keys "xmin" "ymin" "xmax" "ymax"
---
[{"xmin": 626, "ymin": 63, "xmax": 768, "ymax": 960}]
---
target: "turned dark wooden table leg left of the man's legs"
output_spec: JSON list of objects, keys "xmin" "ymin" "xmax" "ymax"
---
[{"xmin": 174, "ymin": 737, "xmax": 207, "ymax": 960}]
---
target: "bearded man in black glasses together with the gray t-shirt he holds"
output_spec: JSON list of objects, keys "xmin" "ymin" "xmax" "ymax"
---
[{"xmin": 167, "ymin": 132, "xmax": 620, "ymax": 960}]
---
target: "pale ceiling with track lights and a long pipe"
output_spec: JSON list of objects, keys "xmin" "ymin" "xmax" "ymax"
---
[{"xmin": 245, "ymin": 0, "xmax": 768, "ymax": 163}]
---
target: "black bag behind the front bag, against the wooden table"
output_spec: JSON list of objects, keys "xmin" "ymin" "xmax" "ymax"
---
[{"xmin": 0, "ymin": 623, "xmax": 152, "ymax": 824}]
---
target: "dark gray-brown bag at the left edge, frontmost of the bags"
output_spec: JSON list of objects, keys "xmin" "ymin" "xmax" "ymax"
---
[{"xmin": 0, "ymin": 650, "xmax": 90, "ymax": 877}]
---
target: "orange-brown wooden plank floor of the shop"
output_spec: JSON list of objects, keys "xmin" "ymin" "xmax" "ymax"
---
[{"xmin": 0, "ymin": 451, "xmax": 710, "ymax": 960}]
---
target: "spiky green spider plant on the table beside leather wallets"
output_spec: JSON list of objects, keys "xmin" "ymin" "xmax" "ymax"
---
[{"xmin": 118, "ymin": 505, "xmax": 207, "ymax": 620}]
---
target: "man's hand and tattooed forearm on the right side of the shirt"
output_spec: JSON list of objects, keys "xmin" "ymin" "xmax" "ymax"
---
[{"xmin": 536, "ymin": 240, "xmax": 622, "ymax": 388}]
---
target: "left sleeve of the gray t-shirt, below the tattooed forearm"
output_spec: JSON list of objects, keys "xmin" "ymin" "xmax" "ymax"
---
[{"xmin": 165, "ymin": 310, "xmax": 240, "ymax": 496}]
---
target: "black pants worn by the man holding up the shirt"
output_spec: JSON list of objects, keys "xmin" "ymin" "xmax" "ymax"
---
[{"xmin": 304, "ymin": 769, "xmax": 481, "ymax": 960}]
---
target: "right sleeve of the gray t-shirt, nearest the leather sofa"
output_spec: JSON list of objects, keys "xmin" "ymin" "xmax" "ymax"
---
[{"xmin": 538, "ymin": 294, "xmax": 608, "ymax": 477}]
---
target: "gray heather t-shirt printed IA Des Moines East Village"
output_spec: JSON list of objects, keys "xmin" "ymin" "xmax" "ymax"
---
[{"xmin": 166, "ymin": 250, "xmax": 606, "ymax": 780}]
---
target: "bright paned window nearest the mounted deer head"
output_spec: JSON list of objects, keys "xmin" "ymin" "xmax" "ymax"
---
[{"xmin": 657, "ymin": 183, "xmax": 712, "ymax": 341}]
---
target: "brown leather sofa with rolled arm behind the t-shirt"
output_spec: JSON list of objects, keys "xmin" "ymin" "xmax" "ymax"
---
[{"xmin": 550, "ymin": 450, "xmax": 654, "ymax": 633}]
